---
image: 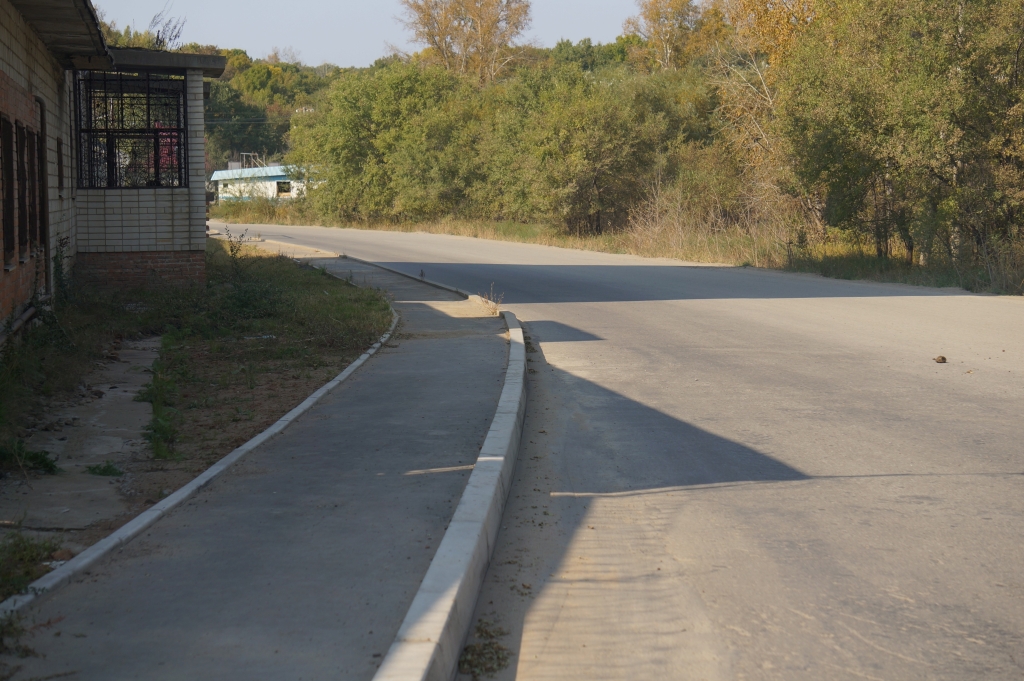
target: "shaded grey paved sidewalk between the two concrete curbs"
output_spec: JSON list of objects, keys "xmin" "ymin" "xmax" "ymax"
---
[{"xmin": 14, "ymin": 258, "xmax": 508, "ymax": 681}]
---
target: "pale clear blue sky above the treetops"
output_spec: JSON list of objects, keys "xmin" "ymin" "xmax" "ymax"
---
[{"xmin": 93, "ymin": 0, "xmax": 636, "ymax": 67}]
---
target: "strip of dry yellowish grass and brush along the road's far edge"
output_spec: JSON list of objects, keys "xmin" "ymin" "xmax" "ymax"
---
[{"xmin": 211, "ymin": 195, "xmax": 1024, "ymax": 295}]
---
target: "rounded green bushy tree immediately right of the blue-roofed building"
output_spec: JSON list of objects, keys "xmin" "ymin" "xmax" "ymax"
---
[{"xmin": 291, "ymin": 62, "xmax": 473, "ymax": 219}]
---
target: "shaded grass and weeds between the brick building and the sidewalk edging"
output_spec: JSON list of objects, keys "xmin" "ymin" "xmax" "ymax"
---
[{"xmin": 0, "ymin": 237, "xmax": 391, "ymax": 610}]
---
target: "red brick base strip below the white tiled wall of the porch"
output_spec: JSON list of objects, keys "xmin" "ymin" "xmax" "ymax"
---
[{"xmin": 75, "ymin": 251, "xmax": 206, "ymax": 288}]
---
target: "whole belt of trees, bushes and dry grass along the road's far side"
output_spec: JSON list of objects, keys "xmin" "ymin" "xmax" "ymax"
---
[{"xmin": 201, "ymin": 0, "xmax": 1024, "ymax": 294}]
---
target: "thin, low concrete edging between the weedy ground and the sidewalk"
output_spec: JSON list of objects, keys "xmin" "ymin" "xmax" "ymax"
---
[{"xmin": 0, "ymin": 310, "xmax": 398, "ymax": 615}]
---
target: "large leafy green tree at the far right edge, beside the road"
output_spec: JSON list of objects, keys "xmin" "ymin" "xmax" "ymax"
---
[{"xmin": 780, "ymin": 0, "xmax": 1024, "ymax": 275}]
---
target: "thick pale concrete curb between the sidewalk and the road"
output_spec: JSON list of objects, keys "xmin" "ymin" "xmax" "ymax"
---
[{"xmin": 374, "ymin": 309, "xmax": 526, "ymax": 681}]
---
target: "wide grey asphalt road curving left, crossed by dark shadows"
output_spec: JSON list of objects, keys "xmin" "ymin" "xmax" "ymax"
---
[{"xmin": 226, "ymin": 226, "xmax": 1024, "ymax": 681}]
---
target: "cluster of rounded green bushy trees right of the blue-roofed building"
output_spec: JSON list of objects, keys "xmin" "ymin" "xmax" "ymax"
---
[{"xmin": 290, "ymin": 59, "xmax": 714, "ymax": 228}]
